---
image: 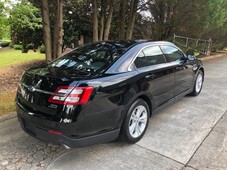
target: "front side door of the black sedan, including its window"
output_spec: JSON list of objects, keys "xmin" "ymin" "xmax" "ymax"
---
[{"xmin": 161, "ymin": 45, "xmax": 194, "ymax": 96}]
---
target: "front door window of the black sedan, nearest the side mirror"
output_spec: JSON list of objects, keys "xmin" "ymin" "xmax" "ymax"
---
[{"xmin": 161, "ymin": 45, "xmax": 185, "ymax": 62}]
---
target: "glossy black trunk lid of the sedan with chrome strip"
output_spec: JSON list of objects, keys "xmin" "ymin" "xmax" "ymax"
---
[{"xmin": 17, "ymin": 67, "xmax": 83, "ymax": 115}]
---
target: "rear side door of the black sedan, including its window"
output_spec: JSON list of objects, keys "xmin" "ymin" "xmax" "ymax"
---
[{"xmin": 134, "ymin": 46, "xmax": 174, "ymax": 109}]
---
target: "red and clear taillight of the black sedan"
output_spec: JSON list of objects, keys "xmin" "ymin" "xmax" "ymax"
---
[{"xmin": 48, "ymin": 86, "xmax": 93, "ymax": 105}]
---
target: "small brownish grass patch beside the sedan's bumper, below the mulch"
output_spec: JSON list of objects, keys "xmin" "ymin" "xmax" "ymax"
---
[{"xmin": 0, "ymin": 92, "xmax": 15, "ymax": 116}]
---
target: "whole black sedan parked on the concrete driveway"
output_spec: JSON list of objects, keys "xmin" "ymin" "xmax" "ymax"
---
[{"xmin": 16, "ymin": 41, "xmax": 204, "ymax": 147}]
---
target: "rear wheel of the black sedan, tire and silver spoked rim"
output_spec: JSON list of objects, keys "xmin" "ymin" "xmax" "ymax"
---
[{"xmin": 121, "ymin": 99, "xmax": 150, "ymax": 143}]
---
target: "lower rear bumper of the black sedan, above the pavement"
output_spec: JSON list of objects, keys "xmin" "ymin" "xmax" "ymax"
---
[{"xmin": 17, "ymin": 102, "xmax": 120, "ymax": 148}]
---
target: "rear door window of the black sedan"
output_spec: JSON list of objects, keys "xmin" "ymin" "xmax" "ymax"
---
[{"xmin": 134, "ymin": 46, "xmax": 166, "ymax": 68}]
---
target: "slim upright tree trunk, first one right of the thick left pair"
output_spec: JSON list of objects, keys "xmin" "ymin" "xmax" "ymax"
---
[{"xmin": 92, "ymin": 0, "xmax": 98, "ymax": 42}]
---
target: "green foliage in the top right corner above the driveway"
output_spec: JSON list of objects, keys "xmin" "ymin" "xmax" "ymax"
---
[{"xmin": 194, "ymin": 0, "xmax": 227, "ymax": 49}]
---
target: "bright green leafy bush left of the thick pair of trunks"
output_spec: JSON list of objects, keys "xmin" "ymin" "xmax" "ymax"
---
[{"xmin": 9, "ymin": 0, "xmax": 42, "ymax": 48}]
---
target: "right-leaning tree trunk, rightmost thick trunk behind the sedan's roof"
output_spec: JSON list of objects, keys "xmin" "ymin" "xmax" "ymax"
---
[{"xmin": 126, "ymin": 0, "xmax": 139, "ymax": 39}]
